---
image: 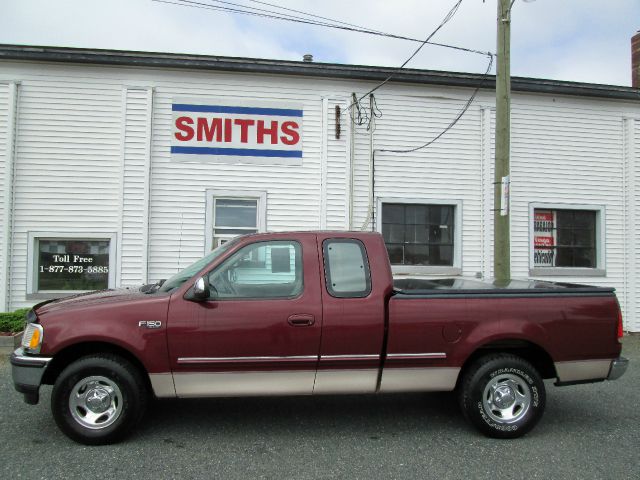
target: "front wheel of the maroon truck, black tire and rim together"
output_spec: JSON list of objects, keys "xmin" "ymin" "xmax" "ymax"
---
[{"xmin": 51, "ymin": 354, "xmax": 148, "ymax": 445}]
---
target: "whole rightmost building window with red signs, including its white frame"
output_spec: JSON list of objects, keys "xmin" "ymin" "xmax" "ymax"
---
[{"xmin": 531, "ymin": 205, "xmax": 604, "ymax": 276}]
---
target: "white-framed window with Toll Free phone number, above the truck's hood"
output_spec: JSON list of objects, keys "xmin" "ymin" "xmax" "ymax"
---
[{"xmin": 27, "ymin": 233, "xmax": 115, "ymax": 296}]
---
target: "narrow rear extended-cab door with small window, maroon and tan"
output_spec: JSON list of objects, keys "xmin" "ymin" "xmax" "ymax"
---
[{"xmin": 314, "ymin": 236, "xmax": 388, "ymax": 394}]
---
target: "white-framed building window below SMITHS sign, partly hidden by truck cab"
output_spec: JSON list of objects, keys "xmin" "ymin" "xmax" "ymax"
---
[{"xmin": 206, "ymin": 191, "xmax": 266, "ymax": 251}]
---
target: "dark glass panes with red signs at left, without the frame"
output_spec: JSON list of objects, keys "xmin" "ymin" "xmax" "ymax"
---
[{"xmin": 533, "ymin": 208, "xmax": 598, "ymax": 268}]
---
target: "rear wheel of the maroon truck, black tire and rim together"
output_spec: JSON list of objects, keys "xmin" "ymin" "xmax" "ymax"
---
[{"xmin": 458, "ymin": 354, "xmax": 546, "ymax": 438}]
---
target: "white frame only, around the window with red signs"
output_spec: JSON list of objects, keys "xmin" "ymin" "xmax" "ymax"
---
[{"xmin": 528, "ymin": 202, "xmax": 607, "ymax": 277}]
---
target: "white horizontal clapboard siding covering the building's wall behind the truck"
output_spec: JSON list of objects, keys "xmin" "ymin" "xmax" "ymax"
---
[{"xmin": 0, "ymin": 62, "xmax": 640, "ymax": 331}]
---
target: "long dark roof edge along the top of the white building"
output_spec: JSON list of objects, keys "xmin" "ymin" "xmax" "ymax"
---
[{"xmin": 0, "ymin": 44, "xmax": 640, "ymax": 101}]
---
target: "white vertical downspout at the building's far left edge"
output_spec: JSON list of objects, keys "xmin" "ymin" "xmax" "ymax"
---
[{"xmin": 0, "ymin": 82, "xmax": 18, "ymax": 311}]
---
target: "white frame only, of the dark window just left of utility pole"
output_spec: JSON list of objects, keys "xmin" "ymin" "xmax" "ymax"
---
[{"xmin": 376, "ymin": 197, "xmax": 463, "ymax": 275}]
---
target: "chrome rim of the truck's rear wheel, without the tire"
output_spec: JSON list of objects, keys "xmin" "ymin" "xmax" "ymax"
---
[{"xmin": 482, "ymin": 373, "xmax": 531, "ymax": 424}]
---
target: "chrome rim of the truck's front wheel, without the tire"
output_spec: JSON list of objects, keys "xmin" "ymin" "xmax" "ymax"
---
[{"xmin": 69, "ymin": 376, "xmax": 122, "ymax": 430}]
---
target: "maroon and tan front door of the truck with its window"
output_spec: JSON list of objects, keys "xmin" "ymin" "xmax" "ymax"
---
[{"xmin": 168, "ymin": 234, "xmax": 322, "ymax": 397}]
